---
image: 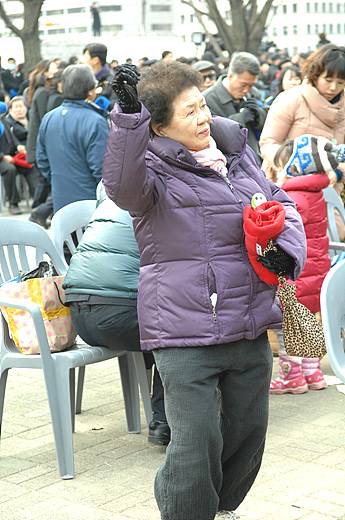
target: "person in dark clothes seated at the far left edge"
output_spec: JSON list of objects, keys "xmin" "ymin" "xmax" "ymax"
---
[{"xmin": 0, "ymin": 101, "xmax": 26, "ymax": 215}]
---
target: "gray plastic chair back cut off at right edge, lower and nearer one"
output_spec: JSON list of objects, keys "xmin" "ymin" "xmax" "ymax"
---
[{"xmin": 321, "ymin": 260, "xmax": 345, "ymax": 383}]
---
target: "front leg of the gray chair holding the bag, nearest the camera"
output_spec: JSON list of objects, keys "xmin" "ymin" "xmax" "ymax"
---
[{"xmin": 44, "ymin": 366, "xmax": 74, "ymax": 479}]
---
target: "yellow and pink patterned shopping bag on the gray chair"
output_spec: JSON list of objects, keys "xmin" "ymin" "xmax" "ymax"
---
[{"xmin": 0, "ymin": 276, "xmax": 77, "ymax": 354}]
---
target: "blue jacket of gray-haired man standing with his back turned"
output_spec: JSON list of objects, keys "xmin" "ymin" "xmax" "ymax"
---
[{"xmin": 36, "ymin": 100, "xmax": 109, "ymax": 213}]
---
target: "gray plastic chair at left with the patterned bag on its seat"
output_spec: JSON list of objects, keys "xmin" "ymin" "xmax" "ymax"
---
[{"xmin": 0, "ymin": 218, "xmax": 152, "ymax": 479}]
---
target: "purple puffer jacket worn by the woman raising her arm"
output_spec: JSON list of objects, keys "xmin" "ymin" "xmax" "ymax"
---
[{"xmin": 103, "ymin": 104, "xmax": 306, "ymax": 350}]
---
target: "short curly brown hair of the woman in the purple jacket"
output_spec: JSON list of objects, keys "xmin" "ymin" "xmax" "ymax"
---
[{"xmin": 138, "ymin": 61, "xmax": 204, "ymax": 130}]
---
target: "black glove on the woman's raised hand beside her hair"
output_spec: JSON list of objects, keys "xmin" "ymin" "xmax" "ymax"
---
[{"xmin": 111, "ymin": 63, "xmax": 141, "ymax": 114}]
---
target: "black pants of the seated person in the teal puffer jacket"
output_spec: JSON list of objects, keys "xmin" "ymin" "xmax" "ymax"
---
[{"xmin": 70, "ymin": 302, "xmax": 166, "ymax": 421}]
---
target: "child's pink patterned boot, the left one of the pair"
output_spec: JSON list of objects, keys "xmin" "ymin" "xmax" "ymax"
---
[{"xmin": 270, "ymin": 350, "xmax": 308, "ymax": 394}]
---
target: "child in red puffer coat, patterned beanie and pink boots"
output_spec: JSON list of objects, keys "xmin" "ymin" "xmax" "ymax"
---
[{"xmin": 270, "ymin": 135, "xmax": 330, "ymax": 394}]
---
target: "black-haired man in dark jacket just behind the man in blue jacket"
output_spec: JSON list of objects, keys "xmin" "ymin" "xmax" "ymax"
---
[{"xmin": 83, "ymin": 43, "xmax": 117, "ymax": 110}]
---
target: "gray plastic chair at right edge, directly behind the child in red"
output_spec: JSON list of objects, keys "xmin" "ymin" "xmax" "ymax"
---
[{"xmin": 322, "ymin": 186, "xmax": 345, "ymax": 256}]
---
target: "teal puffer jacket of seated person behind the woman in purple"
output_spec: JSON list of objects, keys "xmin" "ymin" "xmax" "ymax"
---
[{"xmin": 63, "ymin": 188, "xmax": 140, "ymax": 301}]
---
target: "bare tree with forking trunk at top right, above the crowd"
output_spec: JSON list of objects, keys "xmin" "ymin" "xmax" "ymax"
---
[{"xmin": 181, "ymin": 0, "xmax": 274, "ymax": 55}]
